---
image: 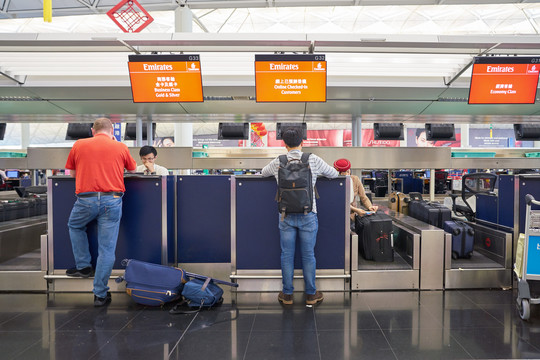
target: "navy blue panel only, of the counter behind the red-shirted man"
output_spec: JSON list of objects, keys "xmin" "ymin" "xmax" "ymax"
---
[{"xmin": 51, "ymin": 177, "xmax": 170, "ymax": 269}]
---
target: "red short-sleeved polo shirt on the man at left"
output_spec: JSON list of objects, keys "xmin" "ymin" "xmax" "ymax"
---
[{"xmin": 66, "ymin": 133, "xmax": 137, "ymax": 194}]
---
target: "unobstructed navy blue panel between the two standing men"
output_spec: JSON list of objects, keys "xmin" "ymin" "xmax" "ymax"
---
[{"xmin": 176, "ymin": 175, "xmax": 231, "ymax": 263}]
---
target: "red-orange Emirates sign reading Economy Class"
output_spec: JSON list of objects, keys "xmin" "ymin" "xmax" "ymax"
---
[{"xmin": 469, "ymin": 57, "xmax": 540, "ymax": 104}]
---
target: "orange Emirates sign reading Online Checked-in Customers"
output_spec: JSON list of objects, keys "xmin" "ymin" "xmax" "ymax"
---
[{"xmin": 255, "ymin": 55, "xmax": 326, "ymax": 102}]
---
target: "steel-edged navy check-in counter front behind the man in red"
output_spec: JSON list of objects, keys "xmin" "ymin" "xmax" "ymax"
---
[{"xmin": 47, "ymin": 175, "xmax": 175, "ymax": 278}]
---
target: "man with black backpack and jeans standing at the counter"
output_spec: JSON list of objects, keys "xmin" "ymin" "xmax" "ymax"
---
[{"xmin": 262, "ymin": 128, "xmax": 338, "ymax": 305}]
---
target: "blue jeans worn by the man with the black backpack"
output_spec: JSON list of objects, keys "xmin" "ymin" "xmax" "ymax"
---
[{"xmin": 279, "ymin": 212, "xmax": 319, "ymax": 295}]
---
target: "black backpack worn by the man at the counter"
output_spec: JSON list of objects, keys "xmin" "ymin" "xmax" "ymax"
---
[{"xmin": 276, "ymin": 153, "xmax": 313, "ymax": 218}]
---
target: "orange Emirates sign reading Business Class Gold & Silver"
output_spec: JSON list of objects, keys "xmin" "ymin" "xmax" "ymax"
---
[{"xmin": 128, "ymin": 55, "xmax": 203, "ymax": 103}]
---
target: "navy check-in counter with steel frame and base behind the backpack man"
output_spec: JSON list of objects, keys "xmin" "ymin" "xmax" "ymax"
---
[{"xmin": 231, "ymin": 176, "xmax": 350, "ymax": 291}]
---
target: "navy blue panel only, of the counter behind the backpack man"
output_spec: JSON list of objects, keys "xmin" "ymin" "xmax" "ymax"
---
[{"xmin": 236, "ymin": 177, "xmax": 349, "ymax": 270}]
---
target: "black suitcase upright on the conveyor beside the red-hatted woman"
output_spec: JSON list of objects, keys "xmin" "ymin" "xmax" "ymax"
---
[{"xmin": 355, "ymin": 213, "xmax": 394, "ymax": 262}]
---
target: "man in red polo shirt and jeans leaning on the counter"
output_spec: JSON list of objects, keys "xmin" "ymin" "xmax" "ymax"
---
[{"xmin": 66, "ymin": 118, "xmax": 137, "ymax": 306}]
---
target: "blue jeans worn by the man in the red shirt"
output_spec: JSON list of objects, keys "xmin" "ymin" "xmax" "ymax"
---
[{"xmin": 68, "ymin": 195, "xmax": 122, "ymax": 297}]
